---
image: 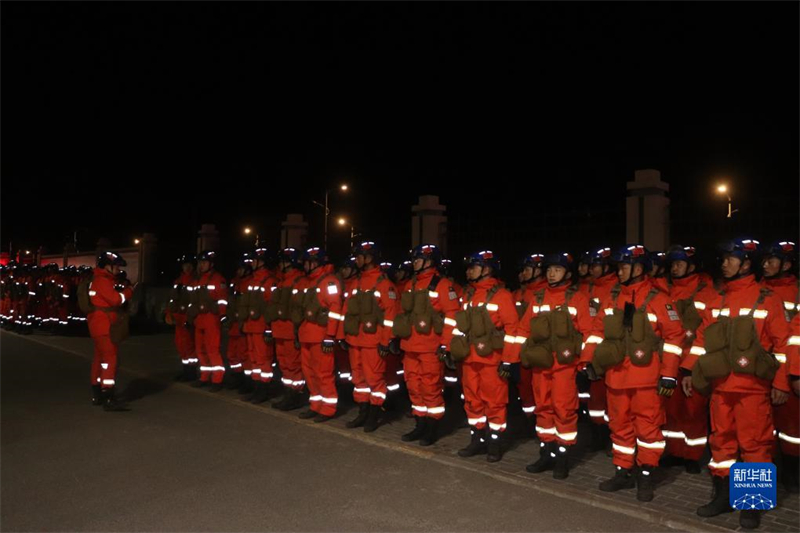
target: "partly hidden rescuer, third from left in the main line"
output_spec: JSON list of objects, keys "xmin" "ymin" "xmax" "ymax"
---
[{"xmin": 225, "ymin": 252, "xmax": 252, "ymax": 390}]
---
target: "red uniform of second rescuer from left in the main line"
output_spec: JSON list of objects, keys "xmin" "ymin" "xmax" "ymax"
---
[{"xmin": 191, "ymin": 270, "xmax": 228, "ymax": 384}]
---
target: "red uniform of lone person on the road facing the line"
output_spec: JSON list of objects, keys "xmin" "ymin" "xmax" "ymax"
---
[{"xmin": 88, "ymin": 268, "xmax": 133, "ymax": 389}]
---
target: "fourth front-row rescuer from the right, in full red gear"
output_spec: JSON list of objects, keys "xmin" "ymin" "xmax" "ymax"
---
[{"xmin": 450, "ymin": 250, "xmax": 519, "ymax": 463}]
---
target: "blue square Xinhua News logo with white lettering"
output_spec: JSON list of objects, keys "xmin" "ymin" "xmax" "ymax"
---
[{"xmin": 730, "ymin": 463, "xmax": 778, "ymax": 511}]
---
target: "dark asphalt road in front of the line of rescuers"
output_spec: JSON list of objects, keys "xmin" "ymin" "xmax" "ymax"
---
[{"xmin": 0, "ymin": 333, "xmax": 669, "ymax": 531}]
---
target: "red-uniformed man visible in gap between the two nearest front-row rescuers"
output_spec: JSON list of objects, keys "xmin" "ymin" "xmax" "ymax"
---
[{"xmin": 662, "ymin": 245, "xmax": 716, "ymax": 474}]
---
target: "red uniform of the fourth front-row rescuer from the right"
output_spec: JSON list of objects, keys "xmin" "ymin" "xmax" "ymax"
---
[{"xmin": 456, "ymin": 277, "xmax": 519, "ymax": 432}]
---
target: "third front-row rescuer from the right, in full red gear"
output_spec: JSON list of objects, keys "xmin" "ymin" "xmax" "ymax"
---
[{"xmin": 516, "ymin": 253, "xmax": 594, "ymax": 479}]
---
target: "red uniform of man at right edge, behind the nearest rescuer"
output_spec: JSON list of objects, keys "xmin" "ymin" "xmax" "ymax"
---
[{"xmin": 764, "ymin": 275, "xmax": 800, "ymax": 457}]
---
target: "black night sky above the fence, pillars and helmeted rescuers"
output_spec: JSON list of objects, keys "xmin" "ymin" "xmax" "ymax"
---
[{"xmin": 0, "ymin": 2, "xmax": 800, "ymax": 264}]
